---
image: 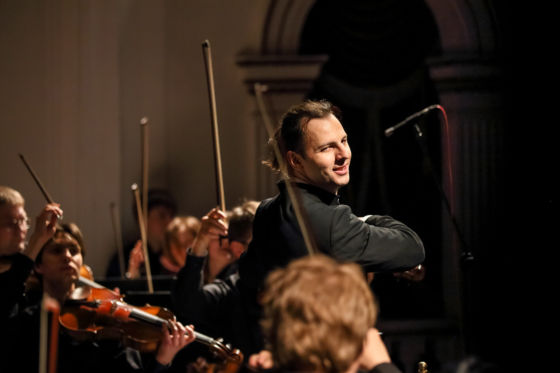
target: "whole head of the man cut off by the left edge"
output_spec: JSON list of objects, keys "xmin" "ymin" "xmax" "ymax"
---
[{"xmin": 0, "ymin": 186, "xmax": 29, "ymax": 256}]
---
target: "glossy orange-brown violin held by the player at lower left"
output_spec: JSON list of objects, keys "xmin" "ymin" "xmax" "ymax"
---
[{"xmin": 59, "ymin": 277, "xmax": 243, "ymax": 373}]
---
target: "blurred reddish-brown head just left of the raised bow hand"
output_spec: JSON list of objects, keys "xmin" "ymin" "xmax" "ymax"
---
[{"xmin": 164, "ymin": 216, "xmax": 200, "ymax": 266}]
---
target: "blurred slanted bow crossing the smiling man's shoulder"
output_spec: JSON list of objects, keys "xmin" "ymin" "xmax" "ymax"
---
[{"xmin": 254, "ymin": 83, "xmax": 318, "ymax": 254}]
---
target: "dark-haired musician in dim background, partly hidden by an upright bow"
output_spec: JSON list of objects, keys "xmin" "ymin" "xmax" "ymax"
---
[{"xmin": 106, "ymin": 189, "xmax": 177, "ymax": 278}]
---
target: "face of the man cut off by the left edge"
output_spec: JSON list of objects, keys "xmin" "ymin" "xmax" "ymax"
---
[{"xmin": 0, "ymin": 205, "xmax": 29, "ymax": 256}]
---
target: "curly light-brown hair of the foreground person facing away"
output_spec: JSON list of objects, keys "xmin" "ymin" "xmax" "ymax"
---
[{"xmin": 261, "ymin": 254, "xmax": 377, "ymax": 372}]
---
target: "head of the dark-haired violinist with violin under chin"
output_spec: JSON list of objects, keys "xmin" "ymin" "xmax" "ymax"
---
[{"xmin": 35, "ymin": 223, "xmax": 84, "ymax": 288}]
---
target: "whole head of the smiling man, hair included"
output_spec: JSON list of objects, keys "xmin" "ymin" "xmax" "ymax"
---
[{"xmin": 265, "ymin": 100, "xmax": 352, "ymax": 193}]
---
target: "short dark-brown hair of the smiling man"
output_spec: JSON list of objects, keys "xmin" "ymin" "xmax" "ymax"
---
[{"xmin": 263, "ymin": 100, "xmax": 341, "ymax": 172}]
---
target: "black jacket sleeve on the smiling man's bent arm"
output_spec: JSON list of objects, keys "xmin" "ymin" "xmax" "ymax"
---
[{"xmin": 329, "ymin": 205, "xmax": 425, "ymax": 272}]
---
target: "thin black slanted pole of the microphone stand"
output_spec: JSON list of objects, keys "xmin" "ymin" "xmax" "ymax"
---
[{"xmin": 413, "ymin": 124, "xmax": 474, "ymax": 353}]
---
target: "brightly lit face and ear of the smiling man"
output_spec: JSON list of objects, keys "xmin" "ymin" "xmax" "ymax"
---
[{"xmin": 288, "ymin": 114, "xmax": 352, "ymax": 194}]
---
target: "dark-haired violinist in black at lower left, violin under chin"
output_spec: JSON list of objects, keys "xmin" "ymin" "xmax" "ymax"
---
[{"xmin": 0, "ymin": 221, "xmax": 194, "ymax": 373}]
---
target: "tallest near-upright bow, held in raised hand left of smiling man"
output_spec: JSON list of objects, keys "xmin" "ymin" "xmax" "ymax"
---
[{"xmin": 202, "ymin": 40, "xmax": 226, "ymax": 211}]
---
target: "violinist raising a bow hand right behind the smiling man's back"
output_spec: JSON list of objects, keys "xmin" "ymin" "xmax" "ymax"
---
[{"xmin": 172, "ymin": 200, "xmax": 258, "ymax": 358}]
